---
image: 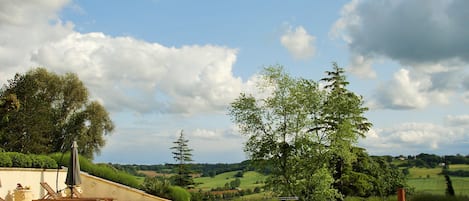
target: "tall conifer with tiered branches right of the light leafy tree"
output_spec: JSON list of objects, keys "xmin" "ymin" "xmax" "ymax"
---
[{"xmin": 311, "ymin": 63, "xmax": 372, "ymax": 193}]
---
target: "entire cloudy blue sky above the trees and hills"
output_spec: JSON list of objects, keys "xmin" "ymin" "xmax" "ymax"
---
[{"xmin": 0, "ymin": 0, "xmax": 469, "ymax": 164}]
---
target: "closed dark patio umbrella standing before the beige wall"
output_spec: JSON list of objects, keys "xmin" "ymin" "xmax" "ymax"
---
[{"xmin": 65, "ymin": 141, "xmax": 81, "ymax": 197}]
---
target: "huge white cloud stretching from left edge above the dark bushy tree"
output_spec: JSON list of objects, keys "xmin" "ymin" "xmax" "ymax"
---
[{"xmin": 0, "ymin": 1, "xmax": 250, "ymax": 114}]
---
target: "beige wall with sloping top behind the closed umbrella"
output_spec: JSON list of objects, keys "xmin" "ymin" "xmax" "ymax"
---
[{"xmin": 0, "ymin": 168, "xmax": 168, "ymax": 201}]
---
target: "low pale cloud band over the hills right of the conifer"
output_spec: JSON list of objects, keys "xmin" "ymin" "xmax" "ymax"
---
[{"xmin": 360, "ymin": 120, "xmax": 469, "ymax": 155}]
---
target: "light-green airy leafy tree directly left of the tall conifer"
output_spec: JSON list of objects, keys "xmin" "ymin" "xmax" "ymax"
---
[{"xmin": 229, "ymin": 66, "xmax": 338, "ymax": 200}]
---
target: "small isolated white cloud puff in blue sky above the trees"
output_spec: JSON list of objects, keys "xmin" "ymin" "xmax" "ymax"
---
[{"xmin": 280, "ymin": 26, "xmax": 316, "ymax": 59}]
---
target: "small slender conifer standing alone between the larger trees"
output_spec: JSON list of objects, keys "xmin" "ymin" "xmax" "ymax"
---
[{"xmin": 171, "ymin": 131, "xmax": 194, "ymax": 187}]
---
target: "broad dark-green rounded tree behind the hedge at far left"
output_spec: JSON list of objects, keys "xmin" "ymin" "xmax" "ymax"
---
[{"xmin": 0, "ymin": 68, "xmax": 114, "ymax": 158}]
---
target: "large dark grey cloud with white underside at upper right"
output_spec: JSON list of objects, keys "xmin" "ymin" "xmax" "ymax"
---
[{"xmin": 331, "ymin": 0, "xmax": 469, "ymax": 110}]
